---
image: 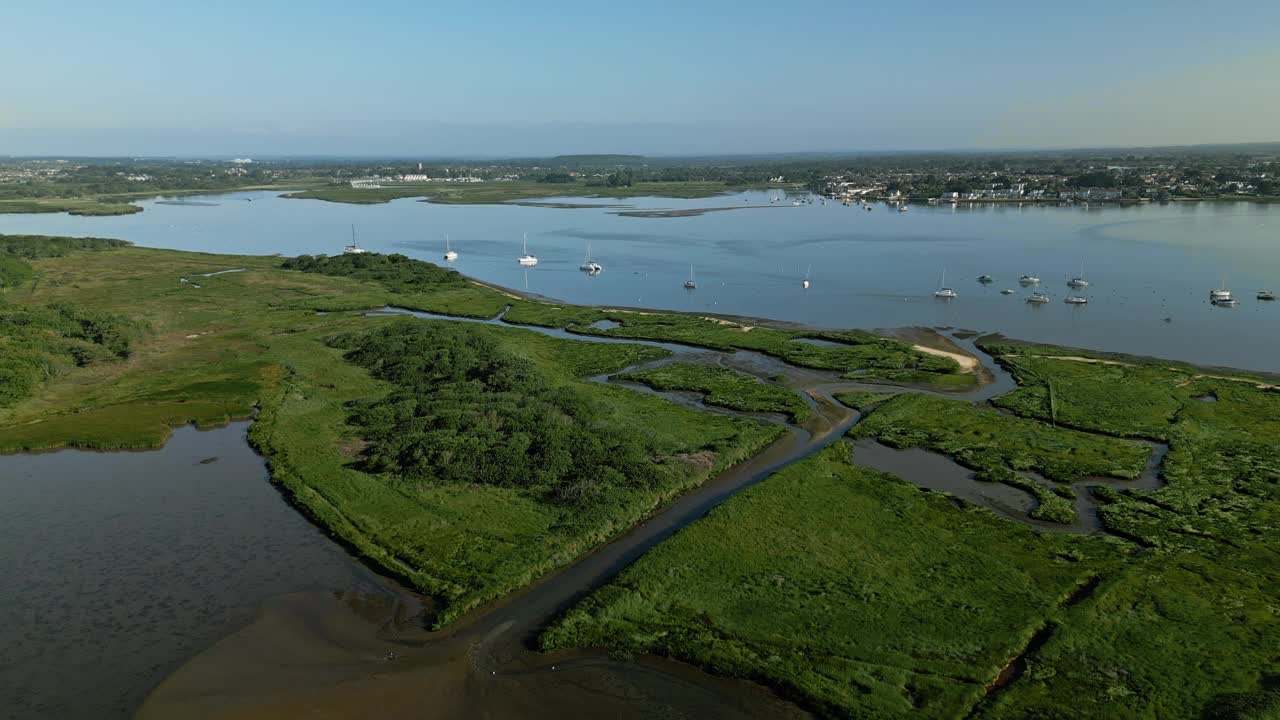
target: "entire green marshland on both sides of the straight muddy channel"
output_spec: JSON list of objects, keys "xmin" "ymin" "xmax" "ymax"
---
[{"xmin": 0, "ymin": 234, "xmax": 1280, "ymax": 720}]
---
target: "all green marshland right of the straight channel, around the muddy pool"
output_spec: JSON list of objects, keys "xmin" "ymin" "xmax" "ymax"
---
[{"xmin": 555, "ymin": 342, "xmax": 1280, "ymax": 719}]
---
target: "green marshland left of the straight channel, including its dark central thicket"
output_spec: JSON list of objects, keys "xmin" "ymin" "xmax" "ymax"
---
[{"xmin": 0, "ymin": 238, "xmax": 782, "ymax": 624}]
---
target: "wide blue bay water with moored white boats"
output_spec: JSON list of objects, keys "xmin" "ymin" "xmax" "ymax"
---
[{"xmin": 0, "ymin": 192, "xmax": 1280, "ymax": 370}]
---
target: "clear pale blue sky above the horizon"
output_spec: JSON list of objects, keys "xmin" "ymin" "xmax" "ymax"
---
[{"xmin": 0, "ymin": 0, "xmax": 1280, "ymax": 156}]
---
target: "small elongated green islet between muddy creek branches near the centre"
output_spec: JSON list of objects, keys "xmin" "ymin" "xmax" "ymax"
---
[{"xmin": 612, "ymin": 363, "xmax": 809, "ymax": 423}]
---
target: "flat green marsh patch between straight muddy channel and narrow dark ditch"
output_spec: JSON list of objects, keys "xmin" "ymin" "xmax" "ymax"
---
[{"xmin": 543, "ymin": 443, "xmax": 1117, "ymax": 717}]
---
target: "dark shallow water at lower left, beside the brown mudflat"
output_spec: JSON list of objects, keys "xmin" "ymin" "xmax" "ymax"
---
[{"xmin": 0, "ymin": 423, "xmax": 383, "ymax": 719}]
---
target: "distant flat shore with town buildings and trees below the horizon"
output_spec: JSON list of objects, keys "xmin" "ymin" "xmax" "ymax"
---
[{"xmin": 0, "ymin": 143, "xmax": 1280, "ymax": 206}]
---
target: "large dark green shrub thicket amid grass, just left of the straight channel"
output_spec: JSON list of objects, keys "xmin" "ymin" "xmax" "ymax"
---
[{"xmin": 332, "ymin": 320, "xmax": 659, "ymax": 509}]
